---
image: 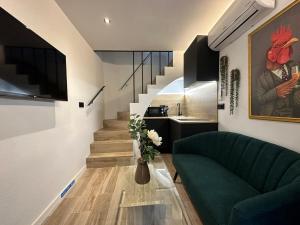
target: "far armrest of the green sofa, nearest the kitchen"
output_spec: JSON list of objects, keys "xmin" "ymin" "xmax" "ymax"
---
[{"xmin": 172, "ymin": 131, "xmax": 218, "ymax": 155}]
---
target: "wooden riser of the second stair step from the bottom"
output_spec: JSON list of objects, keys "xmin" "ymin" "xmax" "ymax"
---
[{"xmin": 91, "ymin": 143, "xmax": 132, "ymax": 153}]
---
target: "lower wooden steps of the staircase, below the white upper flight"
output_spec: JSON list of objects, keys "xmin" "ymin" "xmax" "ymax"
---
[{"xmin": 86, "ymin": 112, "xmax": 133, "ymax": 168}]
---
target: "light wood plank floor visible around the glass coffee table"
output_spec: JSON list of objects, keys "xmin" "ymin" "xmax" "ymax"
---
[{"xmin": 43, "ymin": 155, "xmax": 202, "ymax": 225}]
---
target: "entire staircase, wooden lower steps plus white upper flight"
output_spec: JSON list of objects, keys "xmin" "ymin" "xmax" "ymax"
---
[{"xmin": 86, "ymin": 51, "xmax": 183, "ymax": 168}]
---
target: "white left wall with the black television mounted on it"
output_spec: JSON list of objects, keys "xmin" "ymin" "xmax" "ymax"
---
[{"xmin": 0, "ymin": 0, "xmax": 103, "ymax": 225}]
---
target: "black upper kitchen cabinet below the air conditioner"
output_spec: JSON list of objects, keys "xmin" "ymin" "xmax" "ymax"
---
[{"xmin": 184, "ymin": 35, "xmax": 219, "ymax": 87}]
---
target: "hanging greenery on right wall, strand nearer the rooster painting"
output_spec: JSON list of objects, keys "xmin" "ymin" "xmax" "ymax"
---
[{"xmin": 230, "ymin": 69, "xmax": 241, "ymax": 115}]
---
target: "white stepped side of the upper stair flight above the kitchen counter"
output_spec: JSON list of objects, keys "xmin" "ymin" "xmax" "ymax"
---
[{"xmin": 130, "ymin": 51, "xmax": 184, "ymax": 116}]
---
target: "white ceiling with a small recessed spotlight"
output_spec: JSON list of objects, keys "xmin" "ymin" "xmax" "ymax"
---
[{"xmin": 56, "ymin": 0, "xmax": 233, "ymax": 50}]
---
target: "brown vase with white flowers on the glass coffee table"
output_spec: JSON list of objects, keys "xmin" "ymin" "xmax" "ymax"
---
[{"xmin": 128, "ymin": 114, "xmax": 162, "ymax": 184}]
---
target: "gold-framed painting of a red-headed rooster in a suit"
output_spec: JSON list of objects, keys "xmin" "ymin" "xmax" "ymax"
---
[{"xmin": 248, "ymin": 0, "xmax": 300, "ymax": 122}]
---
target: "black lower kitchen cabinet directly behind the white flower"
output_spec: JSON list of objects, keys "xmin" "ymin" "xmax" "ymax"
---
[{"xmin": 144, "ymin": 118, "xmax": 171, "ymax": 153}]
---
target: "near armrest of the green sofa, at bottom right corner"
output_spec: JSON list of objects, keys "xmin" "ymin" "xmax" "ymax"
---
[{"xmin": 229, "ymin": 182, "xmax": 300, "ymax": 225}]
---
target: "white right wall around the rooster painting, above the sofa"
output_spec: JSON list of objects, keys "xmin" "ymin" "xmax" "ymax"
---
[{"xmin": 219, "ymin": 0, "xmax": 300, "ymax": 152}]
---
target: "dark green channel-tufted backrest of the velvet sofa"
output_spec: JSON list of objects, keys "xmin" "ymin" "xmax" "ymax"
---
[{"xmin": 202, "ymin": 132, "xmax": 300, "ymax": 193}]
